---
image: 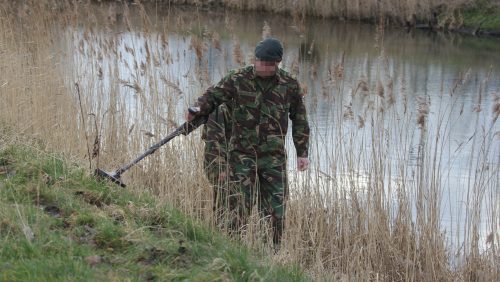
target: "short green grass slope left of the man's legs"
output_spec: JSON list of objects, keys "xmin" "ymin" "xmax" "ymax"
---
[{"xmin": 0, "ymin": 145, "xmax": 306, "ymax": 281}]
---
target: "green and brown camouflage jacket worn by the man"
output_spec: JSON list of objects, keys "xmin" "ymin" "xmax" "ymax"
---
[{"xmin": 197, "ymin": 66, "xmax": 309, "ymax": 157}]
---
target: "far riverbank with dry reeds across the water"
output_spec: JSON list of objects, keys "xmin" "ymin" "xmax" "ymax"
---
[{"xmin": 169, "ymin": 0, "xmax": 500, "ymax": 37}]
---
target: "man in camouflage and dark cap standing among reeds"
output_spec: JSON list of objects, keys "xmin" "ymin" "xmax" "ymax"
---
[{"xmin": 186, "ymin": 38, "xmax": 309, "ymax": 243}]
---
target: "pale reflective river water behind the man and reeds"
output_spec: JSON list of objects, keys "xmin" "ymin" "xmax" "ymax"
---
[{"xmin": 65, "ymin": 2, "xmax": 500, "ymax": 251}]
